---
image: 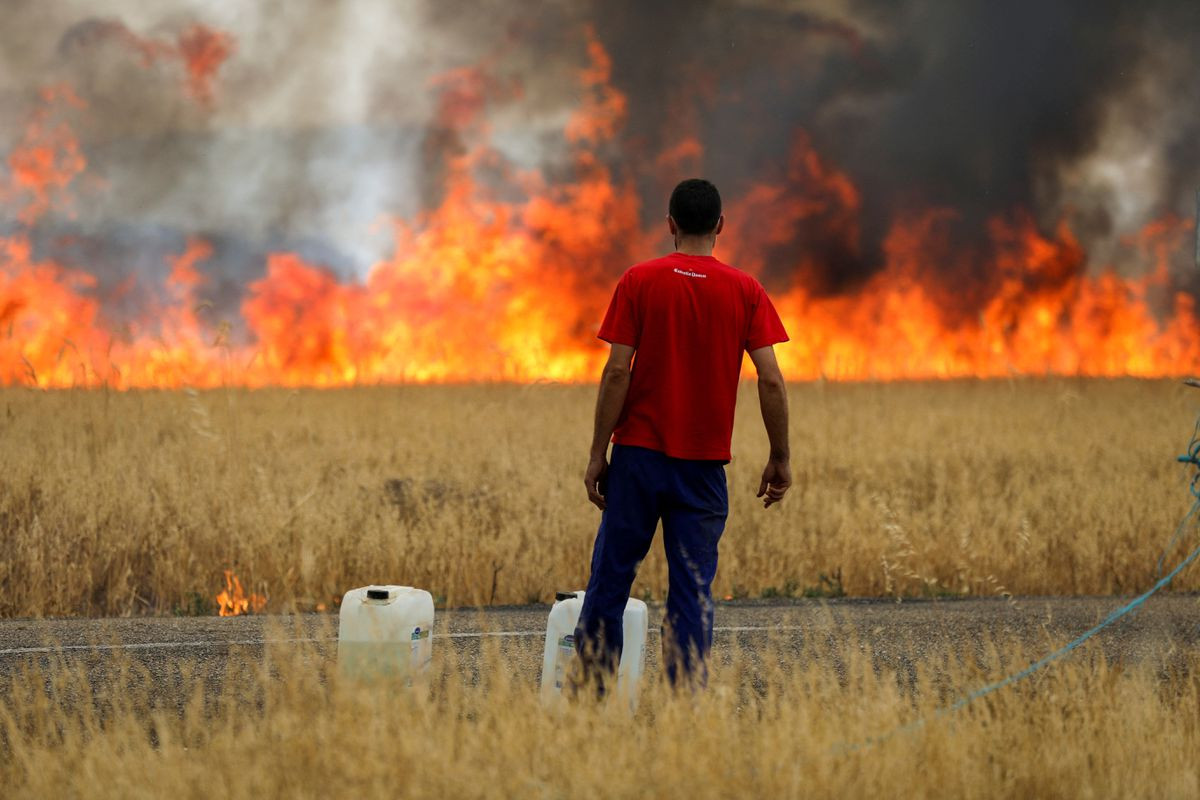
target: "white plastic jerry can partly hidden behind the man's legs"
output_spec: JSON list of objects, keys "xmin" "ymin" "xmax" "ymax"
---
[{"xmin": 541, "ymin": 591, "xmax": 648, "ymax": 708}]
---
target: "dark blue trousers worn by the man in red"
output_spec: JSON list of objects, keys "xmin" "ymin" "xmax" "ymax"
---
[{"xmin": 575, "ymin": 445, "xmax": 730, "ymax": 691}]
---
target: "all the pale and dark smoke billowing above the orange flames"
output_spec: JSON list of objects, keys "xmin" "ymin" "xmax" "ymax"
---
[{"xmin": 0, "ymin": 0, "xmax": 1200, "ymax": 319}]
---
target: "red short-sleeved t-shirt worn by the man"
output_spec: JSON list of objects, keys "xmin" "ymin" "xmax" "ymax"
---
[{"xmin": 599, "ymin": 253, "xmax": 787, "ymax": 461}]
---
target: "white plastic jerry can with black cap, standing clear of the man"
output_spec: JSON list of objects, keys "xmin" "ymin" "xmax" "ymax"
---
[{"xmin": 337, "ymin": 587, "xmax": 433, "ymax": 686}]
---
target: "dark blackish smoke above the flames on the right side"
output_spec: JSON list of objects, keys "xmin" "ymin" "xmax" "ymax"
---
[{"xmin": 571, "ymin": 0, "xmax": 1200, "ymax": 291}]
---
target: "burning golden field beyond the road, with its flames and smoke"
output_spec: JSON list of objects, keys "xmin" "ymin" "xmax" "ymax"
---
[{"xmin": 0, "ymin": 0, "xmax": 1200, "ymax": 615}]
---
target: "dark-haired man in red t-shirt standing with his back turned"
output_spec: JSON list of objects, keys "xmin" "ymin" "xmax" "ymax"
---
[{"xmin": 575, "ymin": 179, "xmax": 792, "ymax": 692}]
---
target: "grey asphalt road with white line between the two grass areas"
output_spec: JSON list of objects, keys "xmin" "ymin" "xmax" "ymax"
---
[{"xmin": 0, "ymin": 595, "xmax": 1200, "ymax": 697}]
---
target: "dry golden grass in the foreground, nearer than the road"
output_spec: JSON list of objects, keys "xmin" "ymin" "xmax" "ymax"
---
[{"xmin": 0, "ymin": 637, "xmax": 1200, "ymax": 799}]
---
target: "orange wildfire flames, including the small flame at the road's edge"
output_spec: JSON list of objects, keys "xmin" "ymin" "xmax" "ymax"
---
[{"xmin": 0, "ymin": 28, "xmax": 1200, "ymax": 388}]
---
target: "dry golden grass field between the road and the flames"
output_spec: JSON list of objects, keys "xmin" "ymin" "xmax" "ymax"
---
[{"xmin": 0, "ymin": 379, "xmax": 1200, "ymax": 616}]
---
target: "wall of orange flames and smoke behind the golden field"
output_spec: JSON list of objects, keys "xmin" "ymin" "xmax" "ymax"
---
[{"xmin": 0, "ymin": 2, "xmax": 1200, "ymax": 389}]
